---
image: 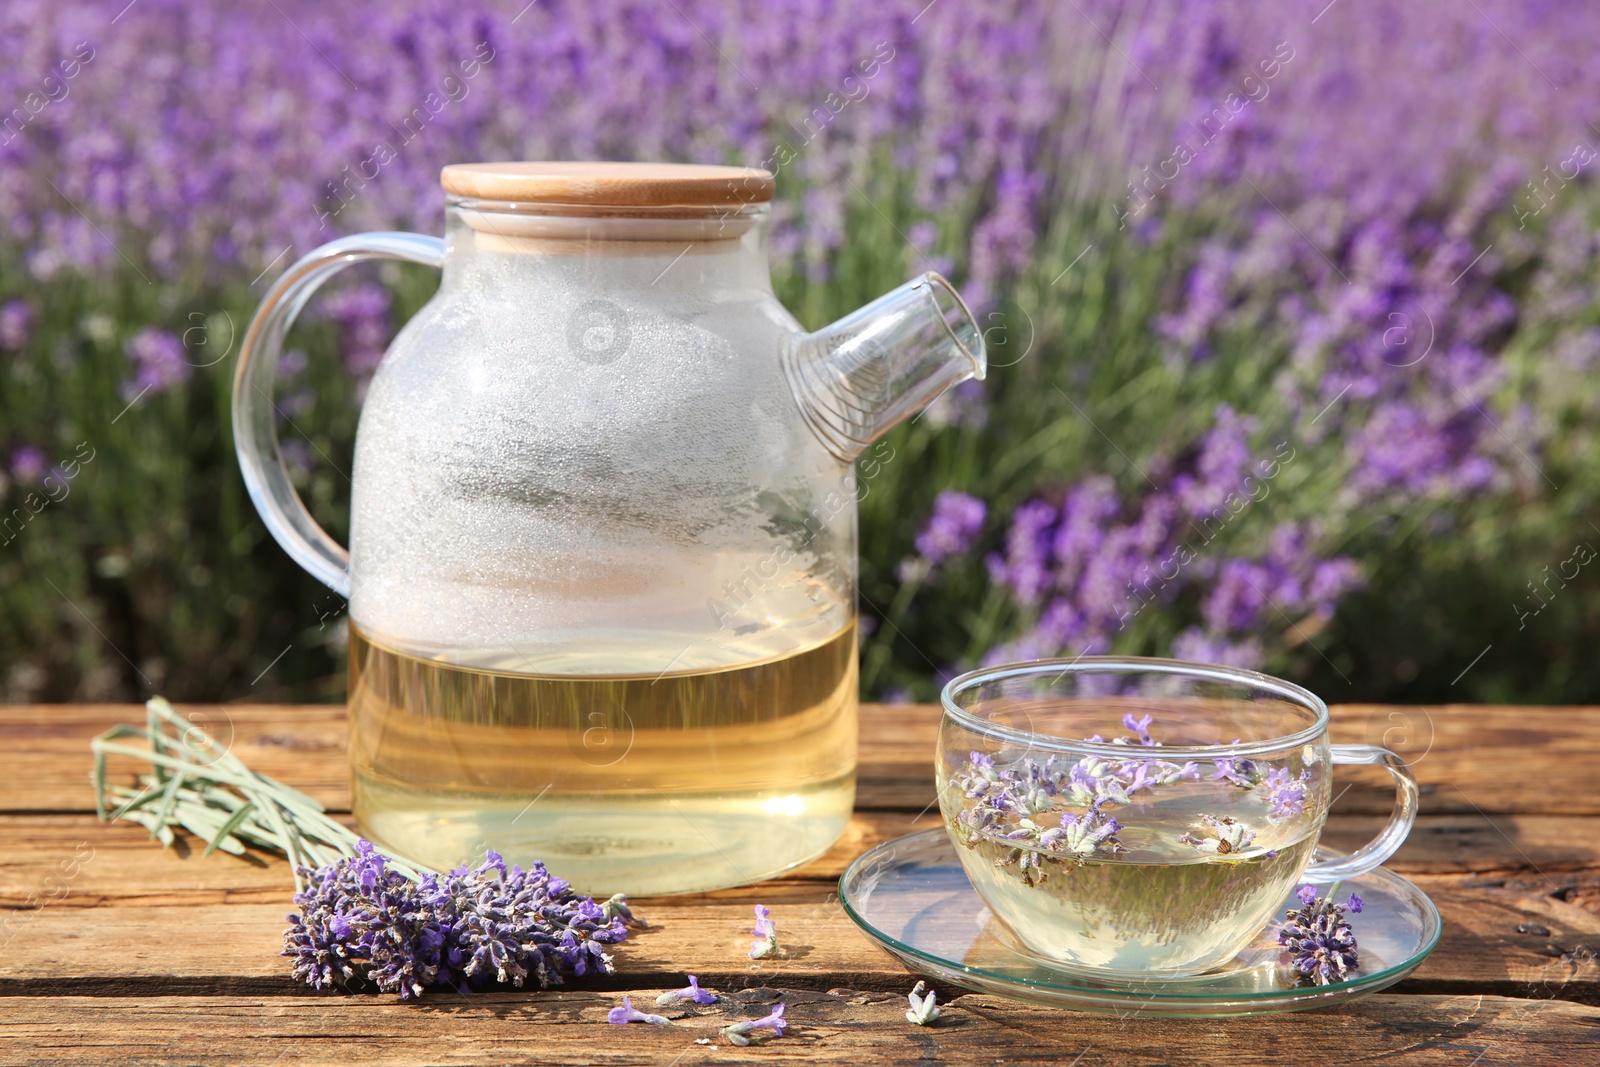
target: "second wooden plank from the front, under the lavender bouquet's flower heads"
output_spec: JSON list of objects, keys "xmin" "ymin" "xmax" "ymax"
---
[{"xmin": 0, "ymin": 857, "xmax": 1600, "ymax": 1003}]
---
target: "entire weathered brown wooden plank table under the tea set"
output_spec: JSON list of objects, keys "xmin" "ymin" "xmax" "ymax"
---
[{"xmin": 0, "ymin": 705, "xmax": 1600, "ymax": 1067}]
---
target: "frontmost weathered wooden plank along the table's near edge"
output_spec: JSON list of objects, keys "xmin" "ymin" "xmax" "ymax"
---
[{"xmin": 0, "ymin": 989, "xmax": 1600, "ymax": 1067}]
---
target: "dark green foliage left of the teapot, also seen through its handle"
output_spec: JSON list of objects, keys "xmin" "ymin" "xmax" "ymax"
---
[{"xmin": 0, "ymin": 259, "xmax": 432, "ymax": 701}]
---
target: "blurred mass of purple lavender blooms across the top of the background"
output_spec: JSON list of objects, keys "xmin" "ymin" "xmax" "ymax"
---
[{"xmin": 0, "ymin": 0, "xmax": 1600, "ymax": 326}]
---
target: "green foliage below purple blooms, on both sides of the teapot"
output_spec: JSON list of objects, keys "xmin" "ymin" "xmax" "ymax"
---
[{"xmin": 0, "ymin": 176, "xmax": 1600, "ymax": 701}]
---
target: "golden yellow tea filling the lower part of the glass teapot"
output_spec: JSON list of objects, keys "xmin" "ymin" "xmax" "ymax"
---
[{"xmin": 350, "ymin": 622, "xmax": 858, "ymax": 894}]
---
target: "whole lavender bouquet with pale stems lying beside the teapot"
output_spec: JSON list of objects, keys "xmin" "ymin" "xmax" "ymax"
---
[{"xmin": 91, "ymin": 697, "xmax": 636, "ymax": 1000}]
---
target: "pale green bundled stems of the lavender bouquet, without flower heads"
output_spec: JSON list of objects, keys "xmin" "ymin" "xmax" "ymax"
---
[{"xmin": 90, "ymin": 697, "xmax": 424, "ymax": 891}]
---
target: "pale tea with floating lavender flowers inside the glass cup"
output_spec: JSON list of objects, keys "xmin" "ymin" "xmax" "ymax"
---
[{"xmin": 941, "ymin": 715, "xmax": 1323, "ymax": 974}]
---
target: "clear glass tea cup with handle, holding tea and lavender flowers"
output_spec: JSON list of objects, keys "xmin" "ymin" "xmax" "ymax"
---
[{"xmin": 936, "ymin": 657, "xmax": 1418, "ymax": 977}]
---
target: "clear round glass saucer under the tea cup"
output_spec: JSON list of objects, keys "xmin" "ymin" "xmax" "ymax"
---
[{"xmin": 838, "ymin": 827, "xmax": 1440, "ymax": 1016}]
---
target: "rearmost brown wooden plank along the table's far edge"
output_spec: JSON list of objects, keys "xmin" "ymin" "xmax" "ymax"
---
[{"xmin": 0, "ymin": 704, "xmax": 1600, "ymax": 814}]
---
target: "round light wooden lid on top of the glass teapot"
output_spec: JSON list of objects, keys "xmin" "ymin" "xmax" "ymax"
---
[{"xmin": 438, "ymin": 162, "xmax": 776, "ymax": 208}]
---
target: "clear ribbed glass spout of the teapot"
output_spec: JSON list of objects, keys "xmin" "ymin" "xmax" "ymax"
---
[{"xmin": 784, "ymin": 274, "xmax": 987, "ymax": 462}]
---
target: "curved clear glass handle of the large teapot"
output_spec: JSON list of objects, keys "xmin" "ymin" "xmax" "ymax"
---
[{"xmin": 234, "ymin": 232, "xmax": 445, "ymax": 600}]
